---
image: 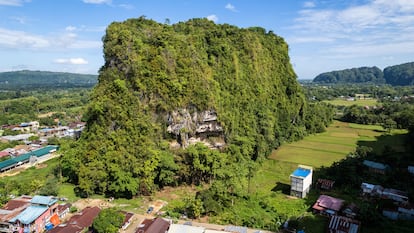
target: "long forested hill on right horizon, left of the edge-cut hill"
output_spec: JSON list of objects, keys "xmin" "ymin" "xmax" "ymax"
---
[{"xmin": 313, "ymin": 66, "xmax": 385, "ymax": 84}]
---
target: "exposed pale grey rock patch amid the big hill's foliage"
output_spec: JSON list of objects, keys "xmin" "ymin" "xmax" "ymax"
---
[{"xmin": 167, "ymin": 108, "xmax": 223, "ymax": 147}]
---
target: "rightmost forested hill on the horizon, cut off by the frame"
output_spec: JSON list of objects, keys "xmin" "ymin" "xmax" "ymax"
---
[{"xmin": 384, "ymin": 62, "xmax": 414, "ymax": 86}]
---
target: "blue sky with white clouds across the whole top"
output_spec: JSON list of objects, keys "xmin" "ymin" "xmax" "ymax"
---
[{"xmin": 0, "ymin": 0, "xmax": 414, "ymax": 79}]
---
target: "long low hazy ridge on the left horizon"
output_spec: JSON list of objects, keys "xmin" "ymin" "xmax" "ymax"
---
[{"xmin": 0, "ymin": 70, "xmax": 98, "ymax": 90}]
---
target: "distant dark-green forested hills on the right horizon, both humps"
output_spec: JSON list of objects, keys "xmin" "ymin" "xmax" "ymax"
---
[{"xmin": 313, "ymin": 62, "xmax": 414, "ymax": 86}]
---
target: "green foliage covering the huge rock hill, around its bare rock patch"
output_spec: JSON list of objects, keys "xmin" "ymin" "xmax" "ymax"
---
[{"xmin": 62, "ymin": 17, "xmax": 333, "ymax": 200}]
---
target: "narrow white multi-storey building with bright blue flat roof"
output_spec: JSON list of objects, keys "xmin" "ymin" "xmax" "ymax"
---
[{"xmin": 290, "ymin": 165, "xmax": 312, "ymax": 198}]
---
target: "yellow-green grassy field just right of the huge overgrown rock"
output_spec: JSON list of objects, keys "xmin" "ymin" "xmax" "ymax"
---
[{"xmin": 270, "ymin": 121, "xmax": 382, "ymax": 168}]
